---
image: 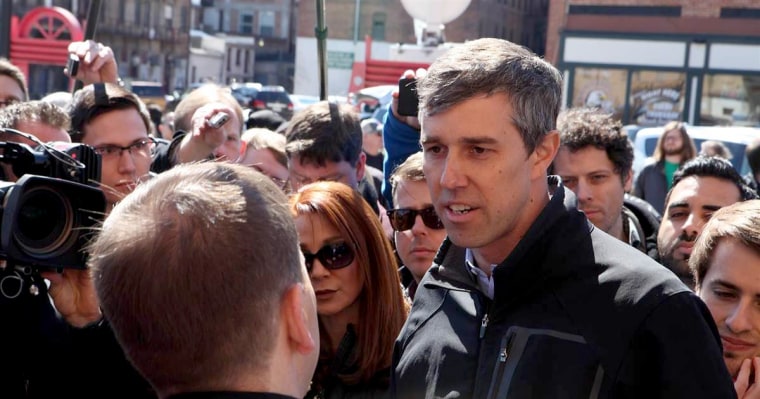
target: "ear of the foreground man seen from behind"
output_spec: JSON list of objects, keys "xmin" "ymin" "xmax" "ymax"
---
[{"xmin": 280, "ymin": 283, "xmax": 319, "ymax": 355}]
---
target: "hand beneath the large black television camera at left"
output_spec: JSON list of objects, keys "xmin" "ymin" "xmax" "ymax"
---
[{"xmin": 40, "ymin": 269, "xmax": 102, "ymax": 327}]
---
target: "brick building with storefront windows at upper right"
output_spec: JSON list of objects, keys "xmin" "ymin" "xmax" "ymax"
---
[{"xmin": 546, "ymin": 0, "xmax": 760, "ymax": 126}]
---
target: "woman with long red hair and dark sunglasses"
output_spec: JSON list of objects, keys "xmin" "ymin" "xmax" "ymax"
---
[{"xmin": 290, "ymin": 182, "xmax": 409, "ymax": 398}]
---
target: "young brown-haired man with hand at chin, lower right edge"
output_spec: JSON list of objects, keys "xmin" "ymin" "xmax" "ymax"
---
[{"xmin": 689, "ymin": 200, "xmax": 760, "ymax": 398}]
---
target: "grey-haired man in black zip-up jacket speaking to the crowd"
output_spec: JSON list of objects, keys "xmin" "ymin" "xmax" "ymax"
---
[{"xmin": 391, "ymin": 39, "xmax": 735, "ymax": 399}]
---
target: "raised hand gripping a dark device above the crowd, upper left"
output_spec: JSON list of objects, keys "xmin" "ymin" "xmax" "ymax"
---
[{"xmin": 64, "ymin": 40, "xmax": 119, "ymax": 86}]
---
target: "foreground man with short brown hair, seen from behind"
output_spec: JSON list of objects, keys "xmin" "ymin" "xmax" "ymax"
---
[{"xmin": 90, "ymin": 162, "xmax": 319, "ymax": 399}]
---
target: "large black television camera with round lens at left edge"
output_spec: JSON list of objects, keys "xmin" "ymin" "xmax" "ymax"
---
[{"xmin": 0, "ymin": 129, "xmax": 106, "ymax": 298}]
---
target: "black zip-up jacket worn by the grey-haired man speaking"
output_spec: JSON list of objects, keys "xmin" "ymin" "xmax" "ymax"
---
[{"xmin": 391, "ymin": 176, "xmax": 736, "ymax": 399}]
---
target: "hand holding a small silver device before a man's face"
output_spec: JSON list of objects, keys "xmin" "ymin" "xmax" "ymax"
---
[{"xmin": 177, "ymin": 103, "xmax": 235, "ymax": 163}]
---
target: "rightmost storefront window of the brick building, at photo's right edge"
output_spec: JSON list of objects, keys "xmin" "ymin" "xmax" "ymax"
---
[{"xmin": 700, "ymin": 74, "xmax": 760, "ymax": 126}]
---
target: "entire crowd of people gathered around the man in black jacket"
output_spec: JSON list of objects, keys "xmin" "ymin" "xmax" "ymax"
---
[{"xmin": 0, "ymin": 35, "xmax": 760, "ymax": 399}]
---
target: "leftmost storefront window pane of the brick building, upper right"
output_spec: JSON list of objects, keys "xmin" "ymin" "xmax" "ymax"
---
[{"xmin": 572, "ymin": 68, "xmax": 628, "ymax": 119}]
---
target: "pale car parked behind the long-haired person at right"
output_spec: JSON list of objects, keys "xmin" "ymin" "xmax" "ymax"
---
[{"xmin": 633, "ymin": 126, "xmax": 760, "ymax": 180}]
